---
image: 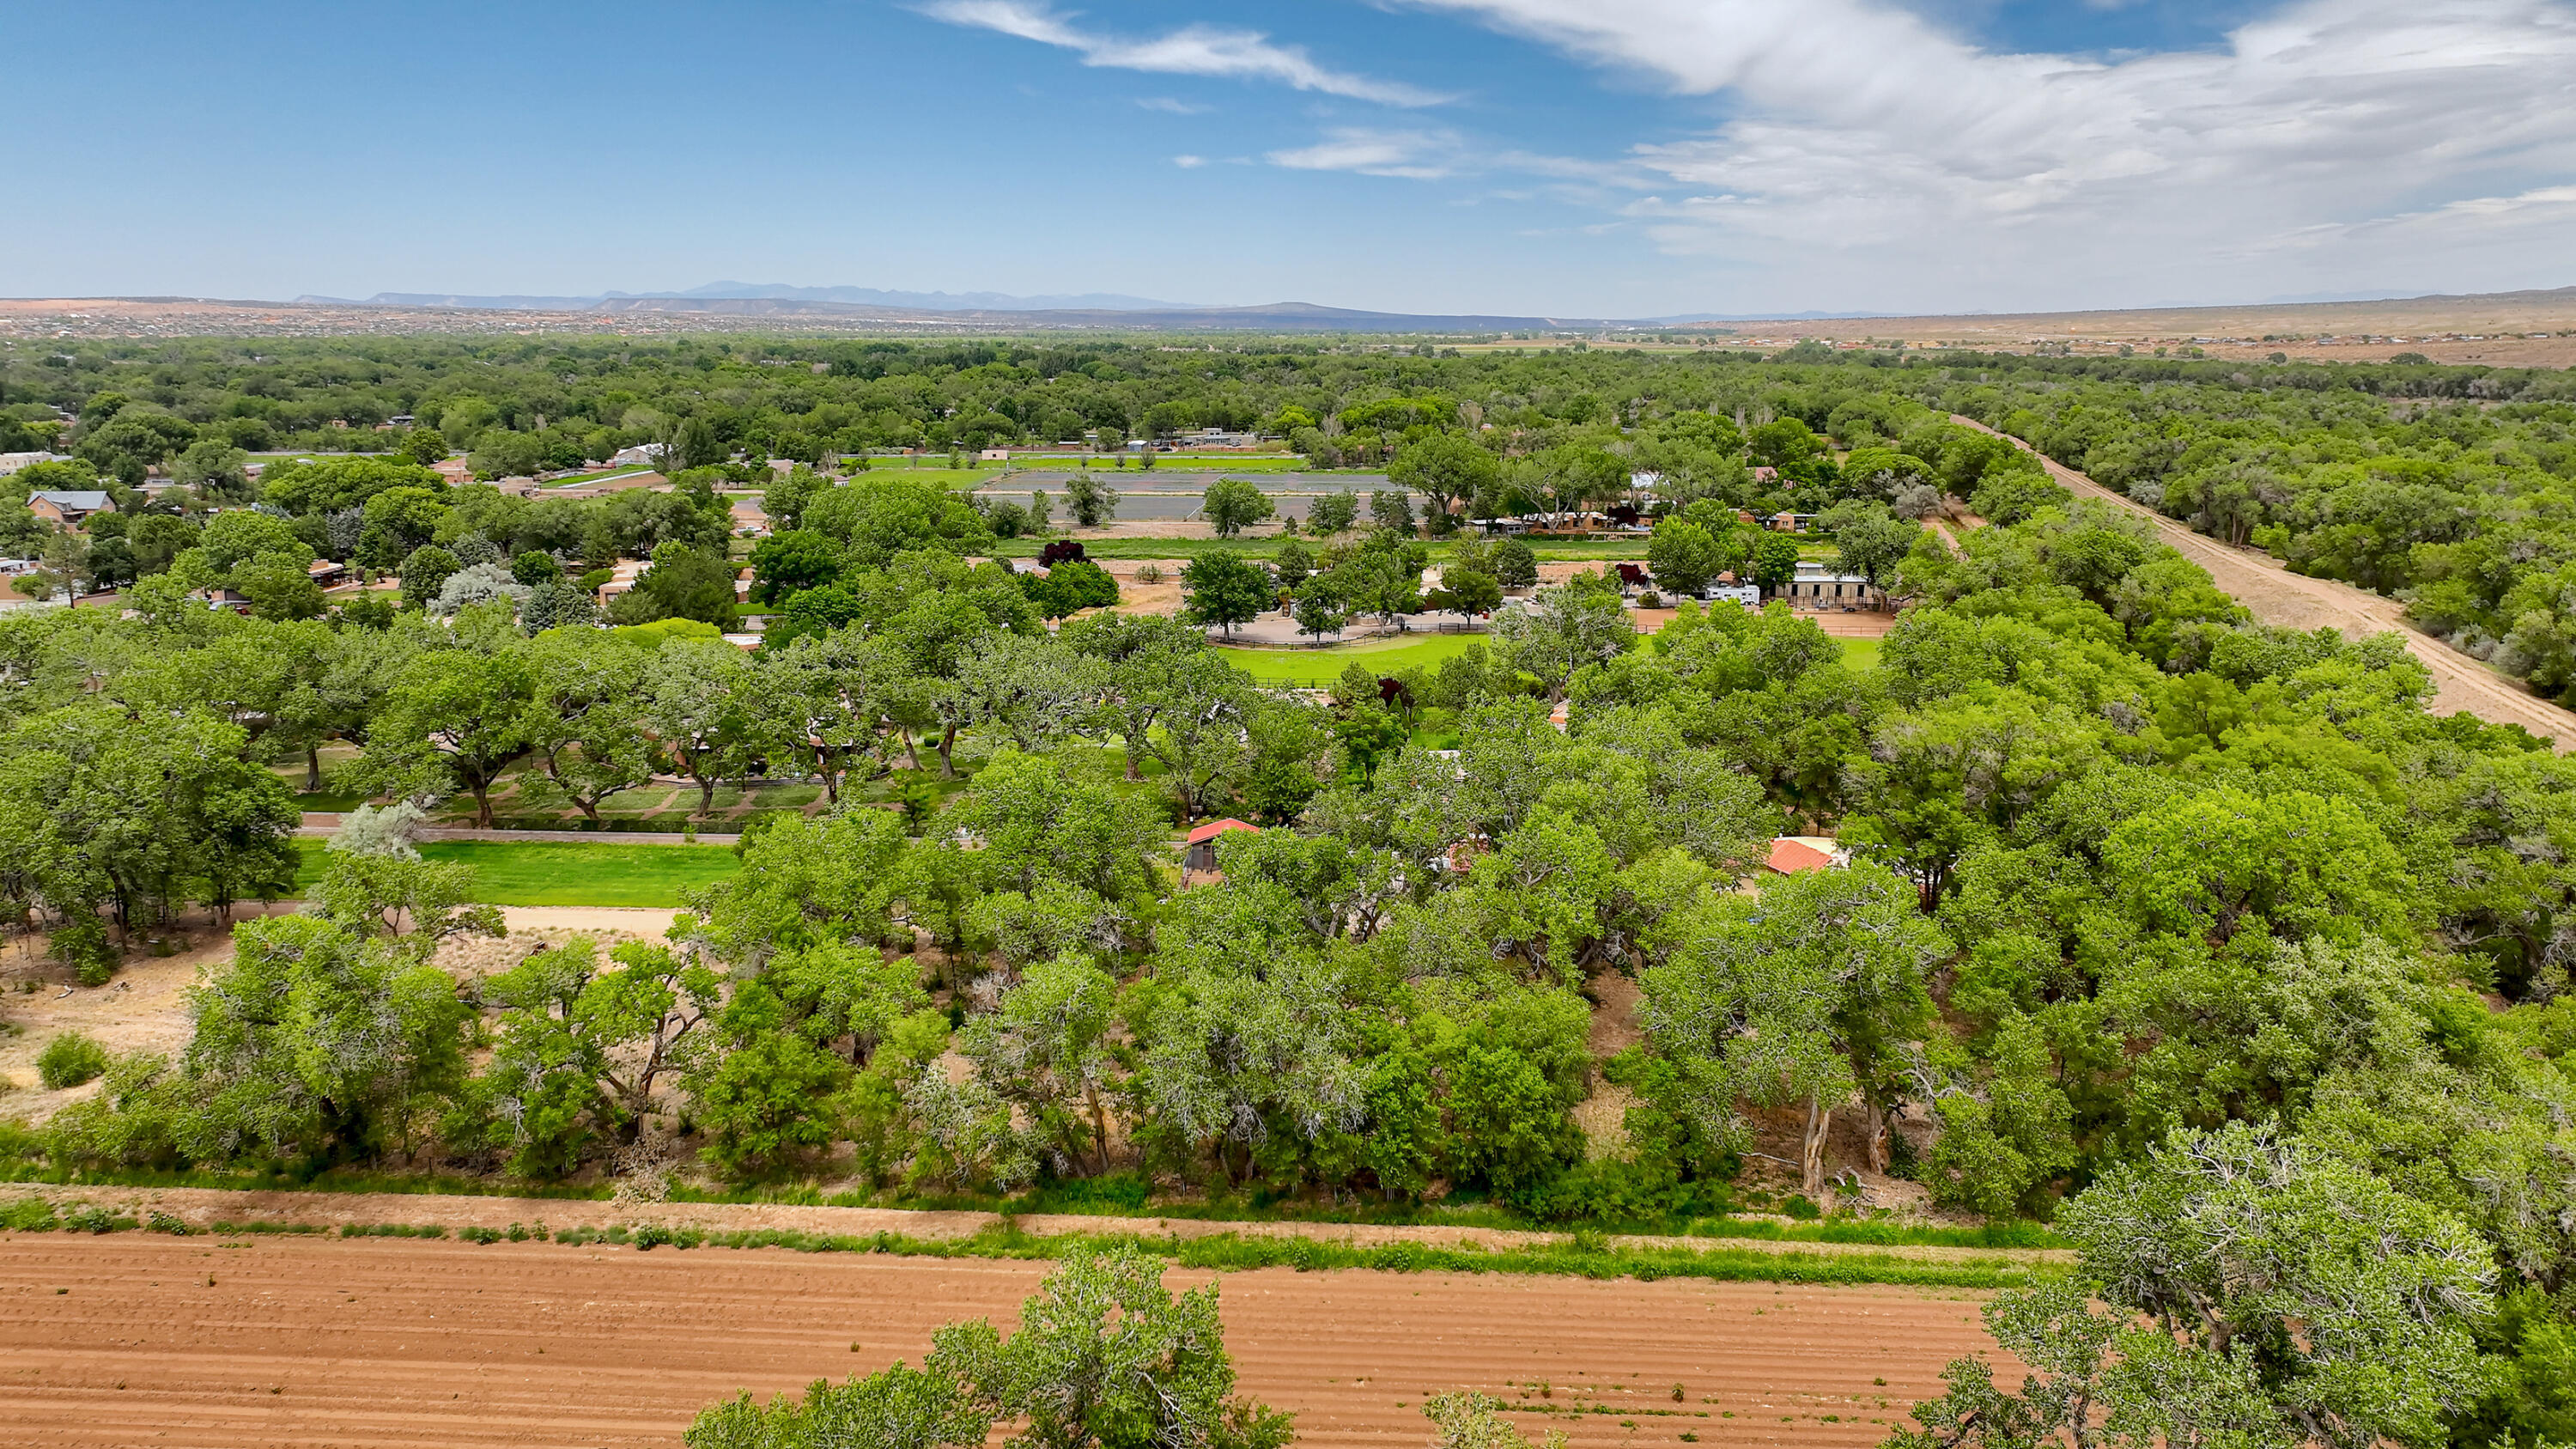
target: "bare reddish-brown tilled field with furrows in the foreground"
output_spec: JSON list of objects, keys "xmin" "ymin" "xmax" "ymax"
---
[{"xmin": 0, "ymin": 1233, "xmax": 1986, "ymax": 1449}]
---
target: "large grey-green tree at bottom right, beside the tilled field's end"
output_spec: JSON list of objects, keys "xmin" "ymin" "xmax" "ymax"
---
[{"xmin": 1888, "ymin": 1122, "xmax": 2496, "ymax": 1449}]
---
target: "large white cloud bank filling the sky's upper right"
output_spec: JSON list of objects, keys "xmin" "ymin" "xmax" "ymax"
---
[{"xmin": 1396, "ymin": 0, "xmax": 2576, "ymax": 304}]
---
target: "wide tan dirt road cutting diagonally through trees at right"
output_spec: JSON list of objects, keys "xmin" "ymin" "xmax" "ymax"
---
[{"xmin": 1950, "ymin": 415, "xmax": 2576, "ymax": 737}]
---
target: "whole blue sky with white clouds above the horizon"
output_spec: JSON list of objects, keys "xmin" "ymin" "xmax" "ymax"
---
[{"xmin": 0, "ymin": 0, "xmax": 2576, "ymax": 317}]
